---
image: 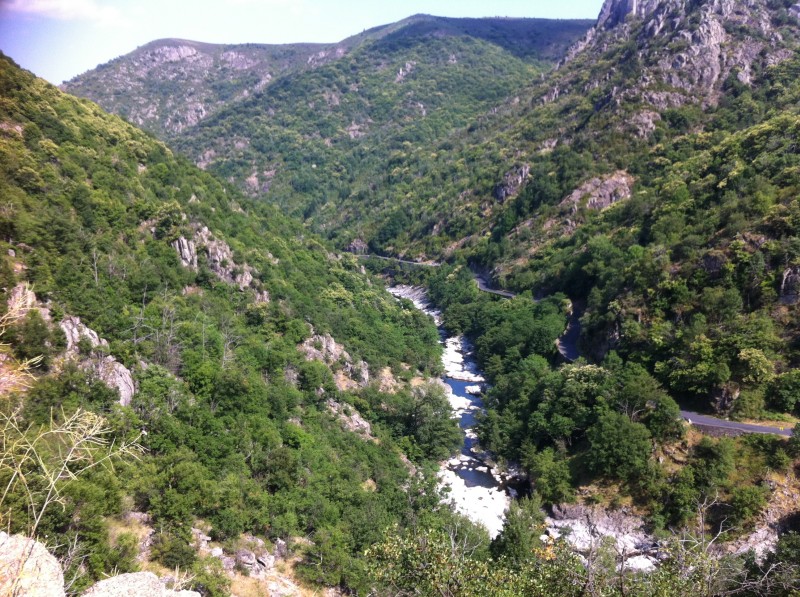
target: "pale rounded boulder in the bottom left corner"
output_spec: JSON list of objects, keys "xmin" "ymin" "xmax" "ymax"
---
[{"xmin": 0, "ymin": 531, "xmax": 64, "ymax": 597}]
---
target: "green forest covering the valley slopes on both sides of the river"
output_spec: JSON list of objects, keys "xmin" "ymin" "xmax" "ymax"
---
[{"xmin": 0, "ymin": 0, "xmax": 800, "ymax": 597}]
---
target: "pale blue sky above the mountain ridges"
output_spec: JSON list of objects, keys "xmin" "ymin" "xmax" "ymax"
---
[{"xmin": 0, "ymin": 0, "xmax": 603, "ymax": 84}]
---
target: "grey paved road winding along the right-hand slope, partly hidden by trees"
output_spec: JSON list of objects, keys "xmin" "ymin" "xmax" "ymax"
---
[{"xmin": 370, "ymin": 255, "xmax": 792, "ymax": 437}]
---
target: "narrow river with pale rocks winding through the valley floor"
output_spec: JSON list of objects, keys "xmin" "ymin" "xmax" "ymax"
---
[{"xmin": 389, "ymin": 286, "xmax": 511, "ymax": 537}]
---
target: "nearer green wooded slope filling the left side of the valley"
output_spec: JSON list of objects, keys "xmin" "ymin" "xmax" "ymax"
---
[{"xmin": 0, "ymin": 57, "xmax": 468, "ymax": 595}]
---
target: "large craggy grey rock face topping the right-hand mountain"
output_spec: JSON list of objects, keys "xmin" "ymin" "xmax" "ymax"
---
[{"xmin": 564, "ymin": 0, "xmax": 788, "ymax": 123}]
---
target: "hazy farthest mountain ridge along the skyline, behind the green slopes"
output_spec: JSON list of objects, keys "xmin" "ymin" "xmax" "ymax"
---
[{"xmin": 63, "ymin": 15, "xmax": 590, "ymax": 139}]
